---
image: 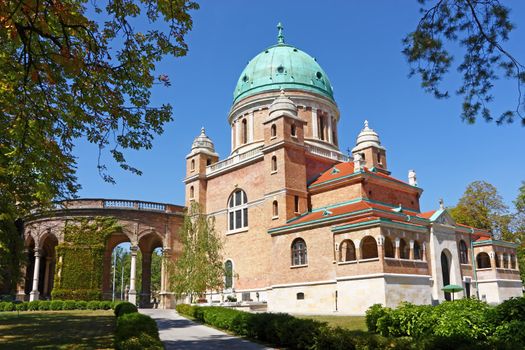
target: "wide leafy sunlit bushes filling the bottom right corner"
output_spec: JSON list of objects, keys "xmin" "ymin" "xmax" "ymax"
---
[{"xmin": 366, "ymin": 297, "xmax": 525, "ymax": 349}]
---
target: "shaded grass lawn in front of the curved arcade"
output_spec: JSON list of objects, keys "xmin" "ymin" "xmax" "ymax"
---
[{"xmin": 0, "ymin": 310, "xmax": 115, "ymax": 349}]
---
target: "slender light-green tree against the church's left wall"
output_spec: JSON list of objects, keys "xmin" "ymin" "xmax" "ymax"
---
[{"xmin": 170, "ymin": 203, "xmax": 224, "ymax": 299}]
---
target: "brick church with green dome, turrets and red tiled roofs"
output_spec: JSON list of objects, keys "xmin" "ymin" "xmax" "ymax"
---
[{"xmin": 184, "ymin": 25, "xmax": 522, "ymax": 314}]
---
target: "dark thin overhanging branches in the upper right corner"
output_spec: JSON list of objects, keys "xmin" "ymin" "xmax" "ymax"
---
[{"xmin": 403, "ymin": 0, "xmax": 525, "ymax": 126}]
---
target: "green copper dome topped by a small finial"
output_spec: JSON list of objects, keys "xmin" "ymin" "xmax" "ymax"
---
[{"xmin": 233, "ymin": 23, "xmax": 334, "ymax": 103}]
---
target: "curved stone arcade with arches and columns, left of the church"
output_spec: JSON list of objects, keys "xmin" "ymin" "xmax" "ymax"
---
[{"xmin": 17, "ymin": 199, "xmax": 184, "ymax": 308}]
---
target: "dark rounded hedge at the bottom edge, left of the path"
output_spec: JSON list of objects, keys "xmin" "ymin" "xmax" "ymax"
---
[{"xmin": 115, "ymin": 312, "xmax": 163, "ymax": 350}]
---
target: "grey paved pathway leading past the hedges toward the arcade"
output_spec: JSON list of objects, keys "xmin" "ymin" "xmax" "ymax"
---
[{"xmin": 140, "ymin": 309, "xmax": 270, "ymax": 350}]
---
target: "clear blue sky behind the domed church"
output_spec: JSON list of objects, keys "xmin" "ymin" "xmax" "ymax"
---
[{"xmin": 75, "ymin": 0, "xmax": 525, "ymax": 210}]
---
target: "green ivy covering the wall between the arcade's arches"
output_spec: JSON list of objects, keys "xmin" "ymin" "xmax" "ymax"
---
[{"xmin": 51, "ymin": 217, "xmax": 122, "ymax": 300}]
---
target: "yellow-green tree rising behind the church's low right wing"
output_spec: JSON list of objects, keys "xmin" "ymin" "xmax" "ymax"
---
[{"xmin": 450, "ymin": 181, "xmax": 510, "ymax": 238}]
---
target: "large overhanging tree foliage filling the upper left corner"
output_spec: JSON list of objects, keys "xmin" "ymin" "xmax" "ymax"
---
[{"xmin": 0, "ymin": 0, "xmax": 198, "ymax": 219}]
